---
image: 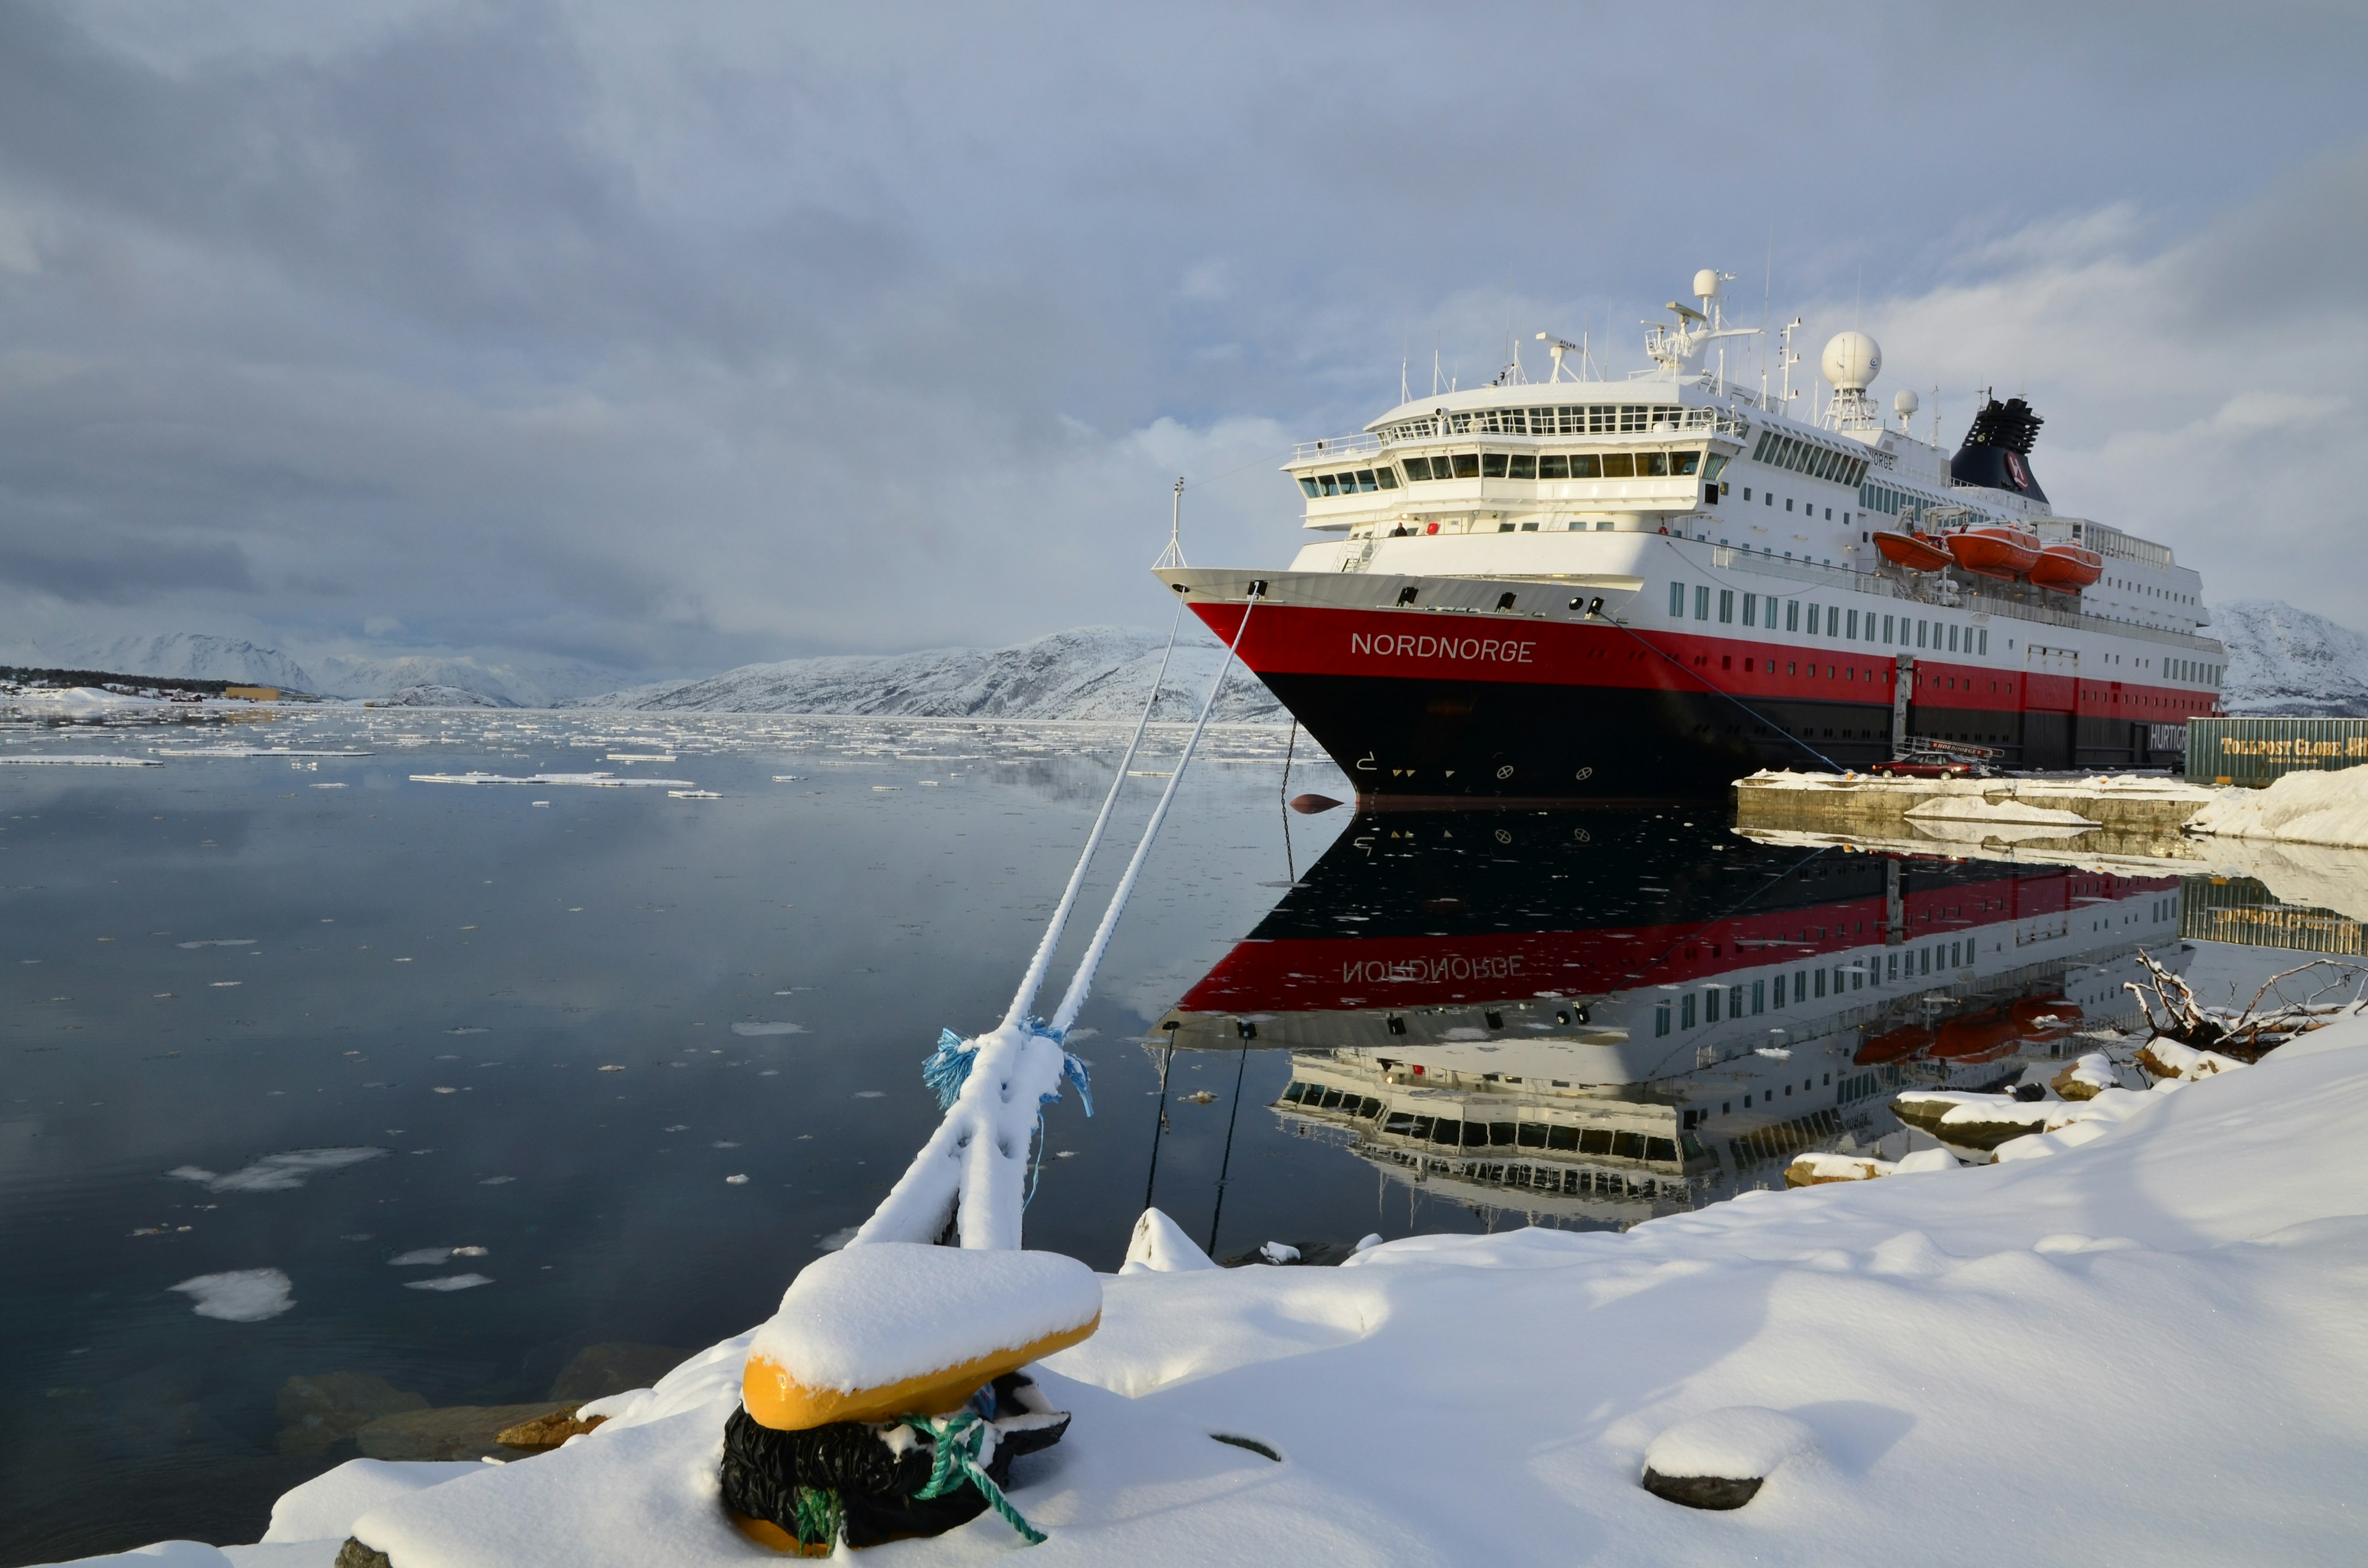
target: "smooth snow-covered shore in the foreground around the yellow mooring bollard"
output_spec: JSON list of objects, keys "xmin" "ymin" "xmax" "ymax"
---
[{"xmin": 69, "ymin": 1019, "xmax": 2368, "ymax": 1568}]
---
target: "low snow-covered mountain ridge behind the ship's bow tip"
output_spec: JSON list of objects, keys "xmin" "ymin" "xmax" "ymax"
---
[{"xmin": 570, "ymin": 623, "xmax": 1283, "ymax": 723}]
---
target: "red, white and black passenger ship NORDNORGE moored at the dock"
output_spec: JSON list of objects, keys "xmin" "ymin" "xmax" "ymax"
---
[{"xmin": 1156, "ymin": 273, "xmax": 2224, "ymax": 800}]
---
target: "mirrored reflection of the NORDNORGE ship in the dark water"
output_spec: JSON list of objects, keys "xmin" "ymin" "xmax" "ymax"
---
[{"xmin": 1161, "ymin": 813, "xmax": 2185, "ymax": 1227}]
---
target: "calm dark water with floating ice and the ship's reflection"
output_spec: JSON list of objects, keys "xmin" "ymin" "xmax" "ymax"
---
[{"xmin": 0, "ymin": 710, "xmax": 2339, "ymax": 1563}]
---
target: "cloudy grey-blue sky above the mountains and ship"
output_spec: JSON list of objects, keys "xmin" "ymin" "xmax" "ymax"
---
[{"xmin": 0, "ymin": 0, "xmax": 2368, "ymax": 679}]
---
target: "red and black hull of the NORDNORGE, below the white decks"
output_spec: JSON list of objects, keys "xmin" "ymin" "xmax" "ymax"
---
[{"xmin": 1193, "ymin": 597, "xmax": 2210, "ymax": 803}]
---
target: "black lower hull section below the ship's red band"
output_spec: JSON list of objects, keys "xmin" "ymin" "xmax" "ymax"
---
[{"xmin": 1265, "ymin": 673, "xmax": 2162, "ymax": 805}]
